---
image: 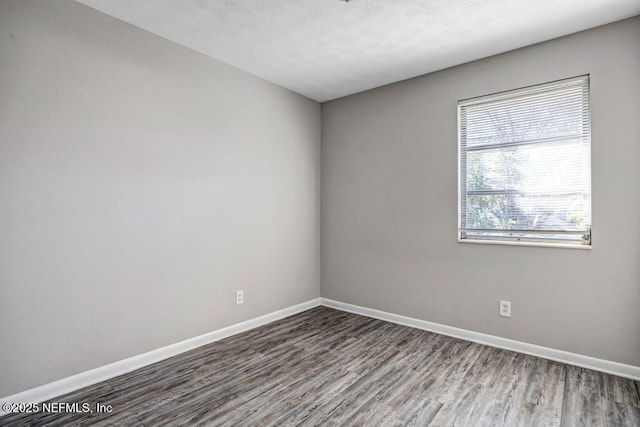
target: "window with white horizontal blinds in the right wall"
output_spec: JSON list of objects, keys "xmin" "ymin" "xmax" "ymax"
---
[{"xmin": 458, "ymin": 76, "xmax": 591, "ymax": 247}]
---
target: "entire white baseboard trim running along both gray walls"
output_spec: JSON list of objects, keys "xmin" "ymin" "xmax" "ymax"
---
[{"xmin": 0, "ymin": 298, "xmax": 640, "ymax": 416}]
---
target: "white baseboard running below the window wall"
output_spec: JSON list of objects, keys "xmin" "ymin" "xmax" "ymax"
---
[{"xmin": 321, "ymin": 298, "xmax": 640, "ymax": 381}]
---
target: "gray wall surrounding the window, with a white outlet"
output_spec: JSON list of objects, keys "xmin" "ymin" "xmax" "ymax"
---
[{"xmin": 321, "ymin": 18, "xmax": 640, "ymax": 366}]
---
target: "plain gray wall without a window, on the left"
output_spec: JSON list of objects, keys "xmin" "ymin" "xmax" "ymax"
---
[{"xmin": 0, "ymin": 0, "xmax": 320, "ymax": 396}]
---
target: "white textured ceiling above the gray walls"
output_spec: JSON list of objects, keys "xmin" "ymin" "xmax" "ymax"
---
[{"xmin": 77, "ymin": 0, "xmax": 640, "ymax": 102}]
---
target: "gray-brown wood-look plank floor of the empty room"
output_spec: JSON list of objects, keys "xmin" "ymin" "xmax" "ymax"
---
[{"xmin": 0, "ymin": 307, "xmax": 640, "ymax": 426}]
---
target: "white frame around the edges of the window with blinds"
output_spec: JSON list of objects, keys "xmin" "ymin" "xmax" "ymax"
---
[{"xmin": 457, "ymin": 74, "xmax": 593, "ymax": 250}]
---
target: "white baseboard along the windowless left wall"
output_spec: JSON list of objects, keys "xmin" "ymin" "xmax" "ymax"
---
[{"xmin": 0, "ymin": 298, "xmax": 320, "ymax": 416}]
